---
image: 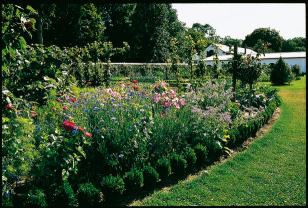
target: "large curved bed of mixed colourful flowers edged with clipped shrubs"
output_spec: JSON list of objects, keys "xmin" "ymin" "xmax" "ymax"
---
[{"xmin": 2, "ymin": 80, "xmax": 279, "ymax": 205}]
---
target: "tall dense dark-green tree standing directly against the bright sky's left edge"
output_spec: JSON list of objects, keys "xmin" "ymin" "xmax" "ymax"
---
[{"xmin": 128, "ymin": 3, "xmax": 183, "ymax": 62}]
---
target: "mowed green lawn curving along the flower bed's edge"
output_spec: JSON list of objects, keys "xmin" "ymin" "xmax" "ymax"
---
[{"xmin": 130, "ymin": 76, "xmax": 306, "ymax": 206}]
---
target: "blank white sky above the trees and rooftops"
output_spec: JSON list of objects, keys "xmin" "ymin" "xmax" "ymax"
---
[{"xmin": 172, "ymin": 3, "xmax": 306, "ymax": 40}]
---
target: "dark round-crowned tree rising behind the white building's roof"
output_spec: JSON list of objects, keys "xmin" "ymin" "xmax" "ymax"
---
[{"xmin": 243, "ymin": 28, "xmax": 283, "ymax": 52}]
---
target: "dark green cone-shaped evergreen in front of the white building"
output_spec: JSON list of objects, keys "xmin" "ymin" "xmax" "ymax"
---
[{"xmin": 270, "ymin": 57, "xmax": 294, "ymax": 85}]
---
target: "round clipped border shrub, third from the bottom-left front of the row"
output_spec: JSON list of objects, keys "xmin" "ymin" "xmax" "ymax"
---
[{"xmin": 123, "ymin": 167, "xmax": 143, "ymax": 191}]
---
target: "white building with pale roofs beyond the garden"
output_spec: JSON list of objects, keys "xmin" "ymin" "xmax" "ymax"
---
[{"xmin": 193, "ymin": 44, "xmax": 306, "ymax": 73}]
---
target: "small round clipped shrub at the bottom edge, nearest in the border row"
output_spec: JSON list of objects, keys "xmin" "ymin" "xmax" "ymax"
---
[{"xmin": 77, "ymin": 183, "xmax": 100, "ymax": 206}]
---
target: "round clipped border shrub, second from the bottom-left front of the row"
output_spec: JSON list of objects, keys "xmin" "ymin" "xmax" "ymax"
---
[{"xmin": 101, "ymin": 174, "xmax": 125, "ymax": 200}]
